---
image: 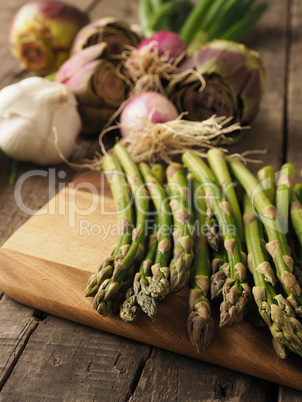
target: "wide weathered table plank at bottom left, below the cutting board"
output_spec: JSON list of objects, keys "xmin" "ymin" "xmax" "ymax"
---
[{"xmin": 0, "ymin": 317, "xmax": 150, "ymax": 402}]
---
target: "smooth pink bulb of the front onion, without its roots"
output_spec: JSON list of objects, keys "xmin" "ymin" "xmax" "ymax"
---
[{"xmin": 120, "ymin": 92, "xmax": 178, "ymax": 137}]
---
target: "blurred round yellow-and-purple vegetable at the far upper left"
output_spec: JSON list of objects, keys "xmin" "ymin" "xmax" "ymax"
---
[{"xmin": 9, "ymin": 1, "xmax": 89, "ymax": 75}]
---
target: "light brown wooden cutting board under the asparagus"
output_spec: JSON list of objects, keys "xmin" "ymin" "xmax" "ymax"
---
[{"xmin": 0, "ymin": 172, "xmax": 302, "ymax": 390}]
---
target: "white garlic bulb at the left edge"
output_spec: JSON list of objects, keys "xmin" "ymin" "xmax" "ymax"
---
[{"xmin": 0, "ymin": 77, "xmax": 82, "ymax": 165}]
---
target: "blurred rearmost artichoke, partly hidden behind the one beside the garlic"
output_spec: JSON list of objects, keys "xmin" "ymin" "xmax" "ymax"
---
[{"xmin": 71, "ymin": 18, "xmax": 140, "ymax": 55}]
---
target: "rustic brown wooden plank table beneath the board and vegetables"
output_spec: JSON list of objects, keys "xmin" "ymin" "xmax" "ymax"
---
[{"xmin": 0, "ymin": 0, "xmax": 302, "ymax": 402}]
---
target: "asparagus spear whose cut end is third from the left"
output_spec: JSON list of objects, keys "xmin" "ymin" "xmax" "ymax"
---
[{"xmin": 139, "ymin": 163, "xmax": 172, "ymax": 300}]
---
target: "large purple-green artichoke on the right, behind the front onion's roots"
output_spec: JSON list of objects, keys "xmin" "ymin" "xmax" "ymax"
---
[{"xmin": 167, "ymin": 40, "xmax": 265, "ymax": 124}]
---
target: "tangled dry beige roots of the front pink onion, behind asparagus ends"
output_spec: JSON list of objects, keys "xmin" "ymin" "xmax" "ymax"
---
[{"xmin": 55, "ymin": 115, "xmax": 266, "ymax": 170}]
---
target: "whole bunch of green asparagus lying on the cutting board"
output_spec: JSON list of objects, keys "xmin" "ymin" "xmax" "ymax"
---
[{"xmin": 85, "ymin": 144, "xmax": 302, "ymax": 358}]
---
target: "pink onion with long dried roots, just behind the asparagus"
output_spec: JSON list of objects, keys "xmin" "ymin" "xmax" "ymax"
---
[{"xmin": 96, "ymin": 92, "xmax": 247, "ymax": 169}]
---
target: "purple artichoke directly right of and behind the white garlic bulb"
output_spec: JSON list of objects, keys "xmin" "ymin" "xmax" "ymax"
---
[{"xmin": 55, "ymin": 43, "xmax": 128, "ymax": 134}]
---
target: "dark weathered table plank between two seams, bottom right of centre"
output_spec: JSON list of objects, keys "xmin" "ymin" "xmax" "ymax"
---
[{"xmin": 130, "ymin": 349, "xmax": 273, "ymax": 402}]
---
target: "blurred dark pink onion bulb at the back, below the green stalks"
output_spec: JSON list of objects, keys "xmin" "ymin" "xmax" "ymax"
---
[{"xmin": 136, "ymin": 31, "xmax": 187, "ymax": 59}]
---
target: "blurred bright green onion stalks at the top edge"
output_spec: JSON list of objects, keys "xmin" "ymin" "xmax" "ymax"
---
[{"xmin": 138, "ymin": 0, "xmax": 267, "ymax": 55}]
